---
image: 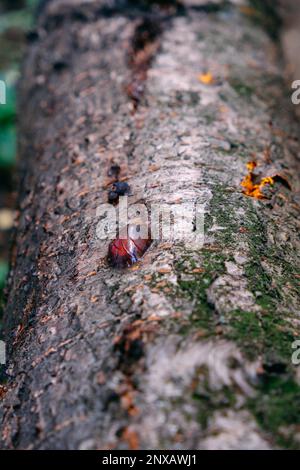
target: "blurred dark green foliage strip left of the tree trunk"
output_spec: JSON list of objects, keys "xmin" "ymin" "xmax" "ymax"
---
[{"xmin": 0, "ymin": 0, "xmax": 39, "ymax": 313}]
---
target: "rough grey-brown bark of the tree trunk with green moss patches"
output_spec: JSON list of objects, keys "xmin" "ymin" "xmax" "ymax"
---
[{"xmin": 1, "ymin": 0, "xmax": 300, "ymax": 449}]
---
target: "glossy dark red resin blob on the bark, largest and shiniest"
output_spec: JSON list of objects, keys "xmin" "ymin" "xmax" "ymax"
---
[{"xmin": 108, "ymin": 225, "xmax": 151, "ymax": 268}]
